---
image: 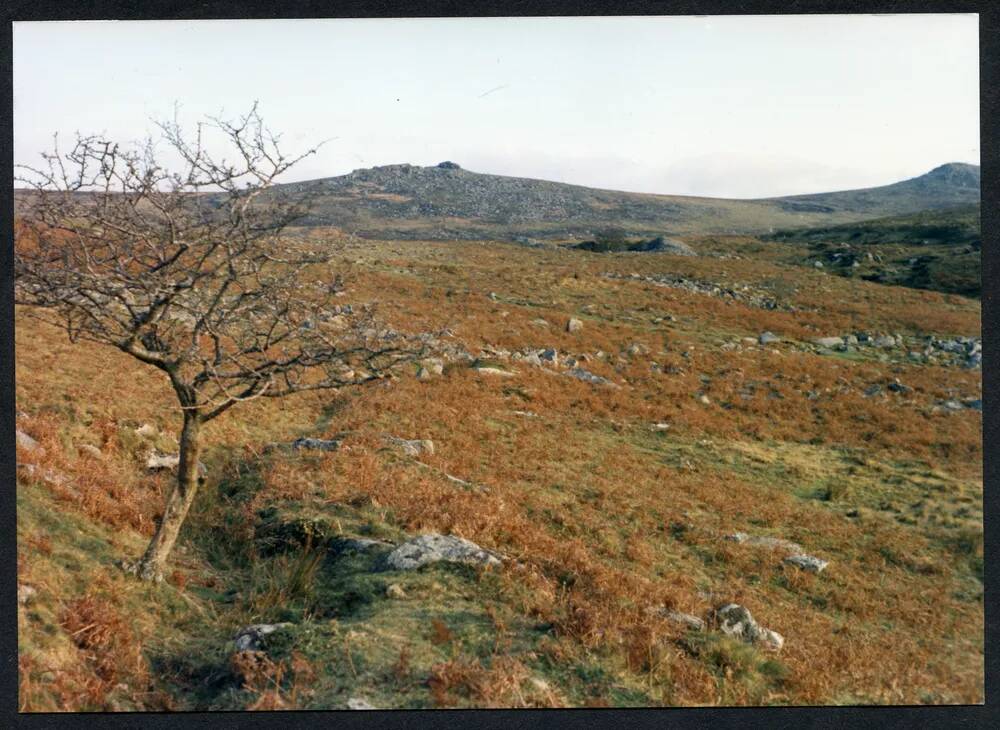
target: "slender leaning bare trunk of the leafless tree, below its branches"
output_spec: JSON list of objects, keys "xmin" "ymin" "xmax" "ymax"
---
[{"xmin": 130, "ymin": 410, "xmax": 201, "ymax": 581}]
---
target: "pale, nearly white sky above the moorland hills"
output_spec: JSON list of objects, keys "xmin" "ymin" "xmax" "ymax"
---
[{"xmin": 13, "ymin": 14, "xmax": 979, "ymax": 198}]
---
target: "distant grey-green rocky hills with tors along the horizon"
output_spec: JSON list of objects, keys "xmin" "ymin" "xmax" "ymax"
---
[{"xmin": 268, "ymin": 162, "xmax": 979, "ymax": 240}]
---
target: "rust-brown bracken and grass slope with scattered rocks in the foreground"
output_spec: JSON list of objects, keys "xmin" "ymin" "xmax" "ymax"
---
[{"xmin": 15, "ymin": 229, "xmax": 984, "ymax": 711}]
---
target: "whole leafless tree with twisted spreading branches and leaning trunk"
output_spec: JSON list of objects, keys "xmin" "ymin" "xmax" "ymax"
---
[{"xmin": 14, "ymin": 105, "xmax": 433, "ymax": 579}]
